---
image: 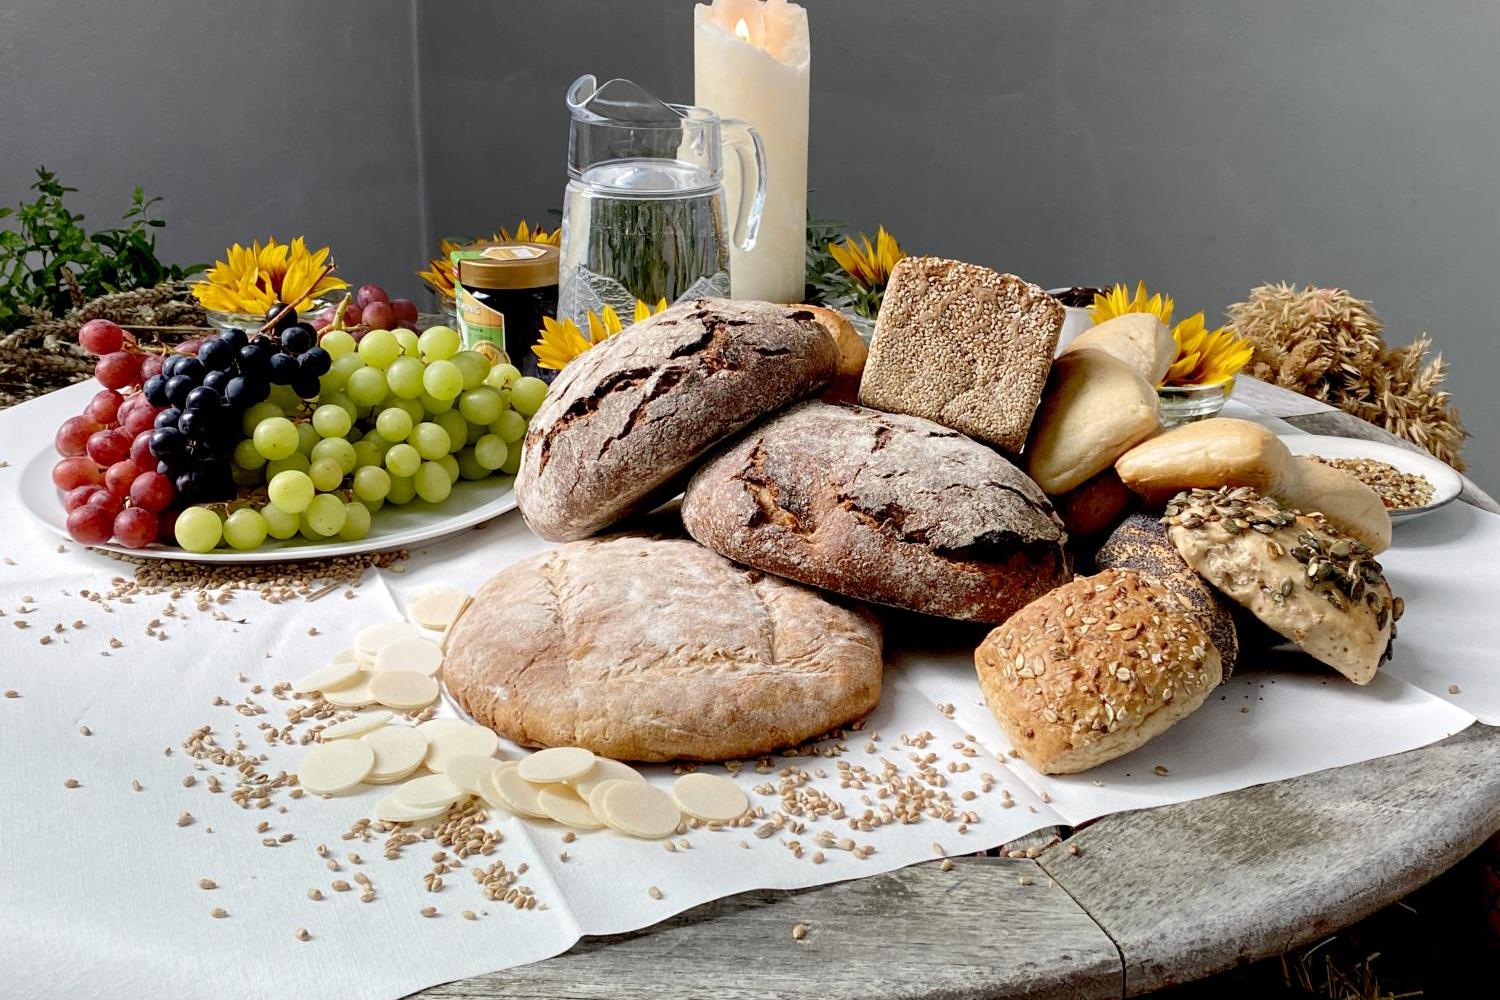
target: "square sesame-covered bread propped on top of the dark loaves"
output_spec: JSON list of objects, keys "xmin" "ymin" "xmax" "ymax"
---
[{"xmin": 860, "ymin": 256, "xmax": 1064, "ymax": 454}]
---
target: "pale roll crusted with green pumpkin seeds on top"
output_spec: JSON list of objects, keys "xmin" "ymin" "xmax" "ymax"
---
[{"xmin": 1166, "ymin": 487, "xmax": 1401, "ymax": 684}]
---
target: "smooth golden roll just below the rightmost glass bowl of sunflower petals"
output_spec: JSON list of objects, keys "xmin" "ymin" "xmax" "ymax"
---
[{"xmin": 1115, "ymin": 417, "xmax": 1292, "ymax": 507}]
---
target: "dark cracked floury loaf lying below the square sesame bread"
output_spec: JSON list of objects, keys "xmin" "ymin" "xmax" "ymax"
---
[{"xmin": 683, "ymin": 402, "xmax": 1070, "ymax": 622}]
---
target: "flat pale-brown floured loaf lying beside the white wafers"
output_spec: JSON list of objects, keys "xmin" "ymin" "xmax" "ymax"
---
[{"xmin": 443, "ymin": 534, "xmax": 881, "ymax": 760}]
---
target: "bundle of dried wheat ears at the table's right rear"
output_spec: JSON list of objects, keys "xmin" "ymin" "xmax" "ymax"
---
[{"xmin": 1229, "ymin": 283, "xmax": 1469, "ymax": 471}]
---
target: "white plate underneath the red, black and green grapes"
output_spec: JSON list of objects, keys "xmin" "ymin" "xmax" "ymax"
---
[{"xmin": 20, "ymin": 436, "xmax": 516, "ymax": 562}]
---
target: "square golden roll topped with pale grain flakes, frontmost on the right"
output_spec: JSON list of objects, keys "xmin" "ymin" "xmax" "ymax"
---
[{"xmin": 974, "ymin": 570, "xmax": 1221, "ymax": 774}]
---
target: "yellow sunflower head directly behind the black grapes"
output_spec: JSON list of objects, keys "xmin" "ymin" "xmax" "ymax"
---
[{"xmin": 192, "ymin": 237, "xmax": 350, "ymax": 315}]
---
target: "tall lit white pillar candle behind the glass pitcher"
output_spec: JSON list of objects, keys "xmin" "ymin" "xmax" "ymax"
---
[{"xmin": 693, "ymin": 0, "xmax": 812, "ymax": 303}]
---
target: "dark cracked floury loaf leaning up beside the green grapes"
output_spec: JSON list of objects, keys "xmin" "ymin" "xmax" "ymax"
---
[{"xmin": 516, "ymin": 298, "xmax": 837, "ymax": 541}]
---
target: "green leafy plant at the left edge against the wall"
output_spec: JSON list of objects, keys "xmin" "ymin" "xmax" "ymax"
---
[{"xmin": 0, "ymin": 166, "xmax": 204, "ymax": 331}]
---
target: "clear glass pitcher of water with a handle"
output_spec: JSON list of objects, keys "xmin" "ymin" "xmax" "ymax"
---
[{"xmin": 558, "ymin": 75, "xmax": 765, "ymax": 330}]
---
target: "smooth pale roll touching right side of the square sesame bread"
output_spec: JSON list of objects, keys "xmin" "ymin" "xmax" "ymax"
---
[{"xmin": 1026, "ymin": 351, "xmax": 1161, "ymax": 493}]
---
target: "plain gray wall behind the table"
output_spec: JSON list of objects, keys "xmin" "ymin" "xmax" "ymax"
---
[{"xmin": 0, "ymin": 0, "xmax": 1500, "ymax": 490}]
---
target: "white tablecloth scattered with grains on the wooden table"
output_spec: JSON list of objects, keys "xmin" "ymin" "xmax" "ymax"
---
[{"xmin": 0, "ymin": 387, "xmax": 1500, "ymax": 1000}]
